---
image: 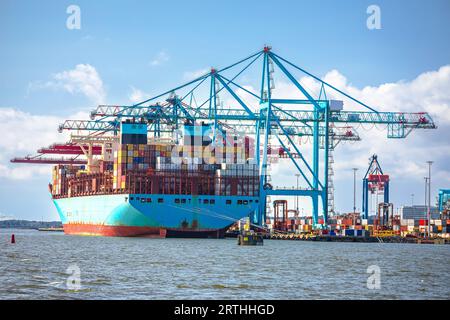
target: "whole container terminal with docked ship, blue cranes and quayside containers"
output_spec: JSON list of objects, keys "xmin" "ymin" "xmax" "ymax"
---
[{"xmin": 11, "ymin": 46, "xmax": 450, "ymax": 240}]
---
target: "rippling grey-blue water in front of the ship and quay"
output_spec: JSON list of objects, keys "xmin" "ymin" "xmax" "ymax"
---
[{"xmin": 0, "ymin": 229, "xmax": 450, "ymax": 299}]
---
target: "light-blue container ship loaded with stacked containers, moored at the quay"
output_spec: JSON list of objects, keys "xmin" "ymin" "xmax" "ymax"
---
[{"xmin": 49, "ymin": 120, "xmax": 259, "ymax": 238}]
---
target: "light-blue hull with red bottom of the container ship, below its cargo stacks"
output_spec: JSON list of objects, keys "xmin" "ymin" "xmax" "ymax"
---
[{"xmin": 53, "ymin": 194, "xmax": 258, "ymax": 237}]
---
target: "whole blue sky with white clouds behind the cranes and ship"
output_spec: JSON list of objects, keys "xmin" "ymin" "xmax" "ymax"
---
[{"xmin": 0, "ymin": 0, "xmax": 450, "ymax": 220}]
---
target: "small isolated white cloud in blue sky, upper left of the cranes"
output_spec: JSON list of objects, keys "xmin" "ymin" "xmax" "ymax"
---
[{"xmin": 28, "ymin": 64, "xmax": 106, "ymax": 104}]
